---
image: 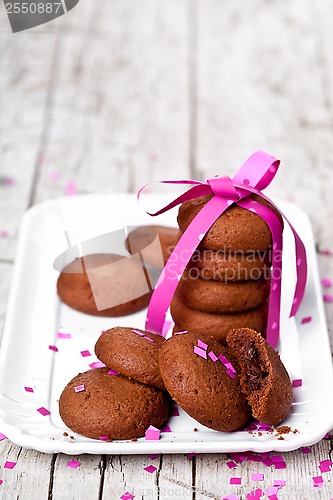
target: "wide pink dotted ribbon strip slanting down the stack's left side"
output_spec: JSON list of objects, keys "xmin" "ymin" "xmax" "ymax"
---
[{"xmin": 145, "ymin": 196, "xmax": 233, "ymax": 336}]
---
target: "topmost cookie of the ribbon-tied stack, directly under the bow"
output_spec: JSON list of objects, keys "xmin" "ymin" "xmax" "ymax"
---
[{"xmin": 177, "ymin": 195, "xmax": 282, "ymax": 253}]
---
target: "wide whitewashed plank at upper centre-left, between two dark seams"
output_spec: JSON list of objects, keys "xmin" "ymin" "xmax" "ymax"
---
[{"xmin": 36, "ymin": 0, "xmax": 189, "ymax": 200}]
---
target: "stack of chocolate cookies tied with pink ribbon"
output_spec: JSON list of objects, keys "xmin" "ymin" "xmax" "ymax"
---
[{"xmin": 171, "ymin": 195, "xmax": 282, "ymax": 342}]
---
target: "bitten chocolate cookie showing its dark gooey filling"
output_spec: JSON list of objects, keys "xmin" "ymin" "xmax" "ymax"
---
[{"xmin": 227, "ymin": 328, "xmax": 293, "ymax": 425}]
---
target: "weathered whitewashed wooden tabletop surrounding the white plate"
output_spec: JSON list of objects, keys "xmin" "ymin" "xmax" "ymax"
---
[{"xmin": 0, "ymin": 0, "xmax": 333, "ymax": 500}]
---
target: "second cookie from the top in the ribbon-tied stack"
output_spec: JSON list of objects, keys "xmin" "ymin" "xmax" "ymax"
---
[{"xmin": 189, "ymin": 247, "xmax": 271, "ymax": 282}]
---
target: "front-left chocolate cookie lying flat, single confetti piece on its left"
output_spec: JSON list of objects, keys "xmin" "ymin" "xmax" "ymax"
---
[{"xmin": 59, "ymin": 368, "xmax": 169, "ymax": 439}]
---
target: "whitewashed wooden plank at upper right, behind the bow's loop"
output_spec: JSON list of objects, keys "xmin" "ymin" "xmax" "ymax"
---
[{"xmin": 196, "ymin": 0, "xmax": 333, "ymax": 248}]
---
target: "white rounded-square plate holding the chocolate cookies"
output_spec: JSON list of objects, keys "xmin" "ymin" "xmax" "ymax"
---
[{"xmin": 0, "ymin": 193, "xmax": 333, "ymax": 454}]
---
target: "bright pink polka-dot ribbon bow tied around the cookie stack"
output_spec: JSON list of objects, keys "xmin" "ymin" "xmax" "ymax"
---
[{"xmin": 138, "ymin": 151, "xmax": 307, "ymax": 347}]
